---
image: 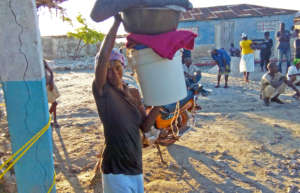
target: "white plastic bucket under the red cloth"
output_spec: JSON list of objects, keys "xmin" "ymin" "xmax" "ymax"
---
[{"xmin": 133, "ymin": 48, "xmax": 187, "ymax": 106}]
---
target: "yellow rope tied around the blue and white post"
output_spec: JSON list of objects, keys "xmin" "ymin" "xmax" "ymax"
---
[{"xmin": 0, "ymin": 115, "xmax": 56, "ymax": 193}]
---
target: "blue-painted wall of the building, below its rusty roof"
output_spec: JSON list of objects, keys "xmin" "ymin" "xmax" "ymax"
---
[{"xmin": 178, "ymin": 14, "xmax": 295, "ymax": 62}]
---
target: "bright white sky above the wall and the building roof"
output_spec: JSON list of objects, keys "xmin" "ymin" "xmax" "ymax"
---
[{"xmin": 38, "ymin": 0, "xmax": 300, "ymax": 36}]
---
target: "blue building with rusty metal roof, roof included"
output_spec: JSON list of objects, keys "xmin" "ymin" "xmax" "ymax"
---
[{"xmin": 179, "ymin": 4, "xmax": 298, "ymax": 60}]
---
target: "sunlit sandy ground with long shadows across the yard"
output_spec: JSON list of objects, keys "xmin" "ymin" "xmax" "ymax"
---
[{"xmin": 0, "ymin": 67, "xmax": 300, "ymax": 193}]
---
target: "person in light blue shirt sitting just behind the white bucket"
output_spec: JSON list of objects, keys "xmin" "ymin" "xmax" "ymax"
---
[{"xmin": 183, "ymin": 57, "xmax": 201, "ymax": 89}]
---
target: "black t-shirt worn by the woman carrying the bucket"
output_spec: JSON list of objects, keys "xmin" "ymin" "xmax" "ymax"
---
[{"xmin": 93, "ymin": 83, "xmax": 143, "ymax": 175}]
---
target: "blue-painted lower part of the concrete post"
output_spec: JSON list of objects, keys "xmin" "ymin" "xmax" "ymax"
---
[{"xmin": 3, "ymin": 78, "xmax": 56, "ymax": 193}]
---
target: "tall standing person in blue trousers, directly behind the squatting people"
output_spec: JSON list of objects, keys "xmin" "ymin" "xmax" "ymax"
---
[{"xmin": 277, "ymin": 23, "xmax": 291, "ymax": 72}]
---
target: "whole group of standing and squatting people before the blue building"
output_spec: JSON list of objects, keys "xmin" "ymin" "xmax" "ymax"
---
[{"xmin": 211, "ymin": 23, "xmax": 300, "ymax": 106}]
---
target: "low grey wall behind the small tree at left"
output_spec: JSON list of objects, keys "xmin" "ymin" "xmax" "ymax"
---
[{"xmin": 42, "ymin": 36, "xmax": 97, "ymax": 59}]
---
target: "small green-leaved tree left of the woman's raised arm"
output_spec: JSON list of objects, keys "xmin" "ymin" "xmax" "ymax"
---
[{"xmin": 64, "ymin": 14, "xmax": 105, "ymax": 59}]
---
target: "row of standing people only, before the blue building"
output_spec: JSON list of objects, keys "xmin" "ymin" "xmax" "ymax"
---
[{"xmin": 211, "ymin": 23, "xmax": 300, "ymax": 87}]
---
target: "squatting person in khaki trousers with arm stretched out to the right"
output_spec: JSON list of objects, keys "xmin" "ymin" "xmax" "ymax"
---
[{"xmin": 260, "ymin": 63, "xmax": 300, "ymax": 106}]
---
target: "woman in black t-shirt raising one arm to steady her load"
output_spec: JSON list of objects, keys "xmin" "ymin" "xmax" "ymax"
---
[{"xmin": 92, "ymin": 15, "xmax": 160, "ymax": 193}]
